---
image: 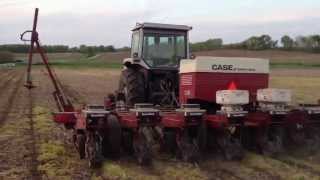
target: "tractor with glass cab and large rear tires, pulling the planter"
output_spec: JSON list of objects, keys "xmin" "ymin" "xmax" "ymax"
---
[{"xmin": 117, "ymin": 23, "xmax": 192, "ymax": 107}]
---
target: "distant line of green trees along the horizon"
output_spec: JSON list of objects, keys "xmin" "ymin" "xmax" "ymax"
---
[{"xmin": 0, "ymin": 34, "xmax": 320, "ymax": 53}]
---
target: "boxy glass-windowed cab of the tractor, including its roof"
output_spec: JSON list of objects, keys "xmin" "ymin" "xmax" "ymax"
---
[{"xmin": 124, "ymin": 23, "xmax": 192, "ymax": 69}]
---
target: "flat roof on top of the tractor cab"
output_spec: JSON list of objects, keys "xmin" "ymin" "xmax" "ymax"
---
[{"xmin": 132, "ymin": 22, "xmax": 192, "ymax": 31}]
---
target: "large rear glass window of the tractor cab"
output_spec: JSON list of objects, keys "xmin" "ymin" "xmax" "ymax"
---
[{"xmin": 143, "ymin": 34, "xmax": 186, "ymax": 68}]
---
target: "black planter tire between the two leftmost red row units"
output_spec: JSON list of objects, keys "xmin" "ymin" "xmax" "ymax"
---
[{"xmin": 102, "ymin": 114, "xmax": 121, "ymax": 158}]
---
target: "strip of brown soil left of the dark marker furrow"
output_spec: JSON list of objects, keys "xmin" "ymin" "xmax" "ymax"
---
[{"xmin": 0, "ymin": 69, "xmax": 40, "ymax": 179}]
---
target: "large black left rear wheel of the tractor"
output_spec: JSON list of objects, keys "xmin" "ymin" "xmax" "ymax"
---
[{"xmin": 119, "ymin": 68, "xmax": 146, "ymax": 106}]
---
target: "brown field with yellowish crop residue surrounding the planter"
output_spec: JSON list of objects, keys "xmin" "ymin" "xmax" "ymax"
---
[{"xmin": 0, "ymin": 68, "xmax": 320, "ymax": 180}]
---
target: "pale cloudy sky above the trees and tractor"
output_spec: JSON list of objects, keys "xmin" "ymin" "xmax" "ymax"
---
[{"xmin": 0, "ymin": 0, "xmax": 320, "ymax": 47}]
